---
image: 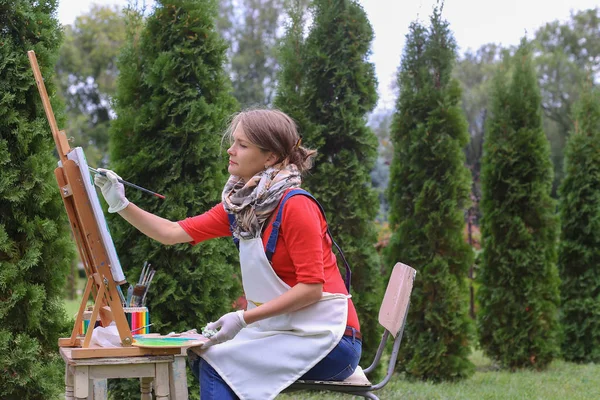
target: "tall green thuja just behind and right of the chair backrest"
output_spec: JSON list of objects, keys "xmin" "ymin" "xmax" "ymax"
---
[{"xmin": 386, "ymin": 9, "xmax": 474, "ymax": 381}]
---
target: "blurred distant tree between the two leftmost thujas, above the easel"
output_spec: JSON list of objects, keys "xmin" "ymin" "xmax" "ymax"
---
[{"xmin": 55, "ymin": 5, "xmax": 126, "ymax": 167}]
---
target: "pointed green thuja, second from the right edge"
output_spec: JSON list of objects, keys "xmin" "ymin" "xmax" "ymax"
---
[{"xmin": 478, "ymin": 40, "xmax": 559, "ymax": 369}]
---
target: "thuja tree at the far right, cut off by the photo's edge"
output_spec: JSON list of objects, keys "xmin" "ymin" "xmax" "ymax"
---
[{"xmin": 558, "ymin": 83, "xmax": 600, "ymax": 362}]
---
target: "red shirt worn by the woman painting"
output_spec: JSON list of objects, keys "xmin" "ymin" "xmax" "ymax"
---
[{"xmin": 179, "ymin": 191, "xmax": 360, "ymax": 330}]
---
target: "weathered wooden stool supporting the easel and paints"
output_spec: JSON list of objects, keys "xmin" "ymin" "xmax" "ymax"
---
[{"xmin": 60, "ymin": 347, "xmax": 188, "ymax": 400}]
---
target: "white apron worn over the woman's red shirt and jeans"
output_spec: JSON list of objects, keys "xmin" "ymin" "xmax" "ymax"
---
[{"xmin": 200, "ymin": 238, "xmax": 349, "ymax": 400}]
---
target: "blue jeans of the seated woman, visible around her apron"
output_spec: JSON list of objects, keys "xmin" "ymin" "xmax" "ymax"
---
[{"xmin": 191, "ymin": 336, "xmax": 362, "ymax": 400}]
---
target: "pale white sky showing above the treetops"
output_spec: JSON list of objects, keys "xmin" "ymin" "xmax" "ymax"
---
[{"xmin": 58, "ymin": 0, "xmax": 600, "ymax": 108}]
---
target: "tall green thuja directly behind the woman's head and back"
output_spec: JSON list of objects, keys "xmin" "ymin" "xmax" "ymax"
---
[{"xmin": 276, "ymin": 0, "xmax": 383, "ymax": 360}]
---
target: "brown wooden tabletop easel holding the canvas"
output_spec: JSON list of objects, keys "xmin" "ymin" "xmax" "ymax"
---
[{"xmin": 27, "ymin": 50, "xmax": 180, "ymax": 358}]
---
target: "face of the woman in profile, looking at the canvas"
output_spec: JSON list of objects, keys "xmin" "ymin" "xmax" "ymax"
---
[{"xmin": 227, "ymin": 123, "xmax": 275, "ymax": 182}]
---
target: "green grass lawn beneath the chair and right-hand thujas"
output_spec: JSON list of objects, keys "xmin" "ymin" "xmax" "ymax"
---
[{"xmin": 278, "ymin": 351, "xmax": 600, "ymax": 400}]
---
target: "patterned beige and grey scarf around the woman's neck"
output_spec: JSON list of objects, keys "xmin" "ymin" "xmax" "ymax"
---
[{"xmin": 222, "ymin": 164, "xmax": 302, "ymax": 239}]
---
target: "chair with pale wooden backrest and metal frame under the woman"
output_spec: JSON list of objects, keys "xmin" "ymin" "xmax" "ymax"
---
[{"xmin": 284, "ymin": 263, "xmax": 416, "ymax": 400}]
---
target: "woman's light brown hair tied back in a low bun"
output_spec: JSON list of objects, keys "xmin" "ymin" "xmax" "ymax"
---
[{"xmin": 224, "ymin": 108, "xmax": 317, "ymax": 173}]
